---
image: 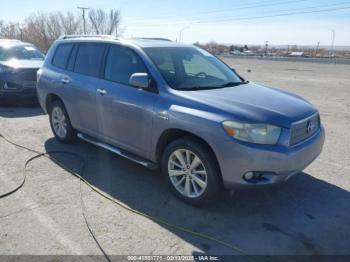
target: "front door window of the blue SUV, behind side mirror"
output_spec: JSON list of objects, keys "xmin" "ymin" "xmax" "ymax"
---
[{"xmin": 105, "ymin": 46, "xmax": 147, "ymax": 85}]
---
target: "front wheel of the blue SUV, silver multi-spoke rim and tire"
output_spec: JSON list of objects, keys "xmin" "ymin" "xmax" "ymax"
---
[{"xmin": 161, "ymin": 138, "xmax": 220, "ymax": 206}]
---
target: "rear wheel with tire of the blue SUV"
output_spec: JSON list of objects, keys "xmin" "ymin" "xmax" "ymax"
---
[{"xmin": 49, "ymin": 100, "xmax": 77, "ymax": 144}]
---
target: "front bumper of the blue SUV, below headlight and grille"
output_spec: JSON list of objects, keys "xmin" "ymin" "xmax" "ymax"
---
[{"xmin": 216, "ymin": 126, "xmax": 325, "ymax": 189}]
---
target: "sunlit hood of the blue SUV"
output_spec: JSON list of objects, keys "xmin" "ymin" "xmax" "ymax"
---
[{"xmin": 176, "ymin": 83, "xmax": 317, "ymax": 127}]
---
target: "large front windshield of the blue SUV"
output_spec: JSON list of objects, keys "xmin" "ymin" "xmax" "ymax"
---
[{"xmin": 144, "ymin": 47, "xmax": 244, "ymax": 90}]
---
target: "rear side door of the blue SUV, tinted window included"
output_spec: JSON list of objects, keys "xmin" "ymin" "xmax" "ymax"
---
[{"xmin": 62, "ymin": 43, "xmax": 106, "ymax": 136}]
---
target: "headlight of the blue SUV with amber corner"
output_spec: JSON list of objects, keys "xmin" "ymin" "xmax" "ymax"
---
[{"xmin": 222, "ymin": 121, "xmax": 281, "ymax": 145}]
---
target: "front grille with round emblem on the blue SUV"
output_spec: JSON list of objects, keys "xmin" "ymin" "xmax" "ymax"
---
[{"xmin": 290, "ymin": 114, "xmax": 321, "ymax": 146}]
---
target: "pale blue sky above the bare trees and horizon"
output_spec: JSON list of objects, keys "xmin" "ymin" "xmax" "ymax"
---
[{"xmin": 0, "ymin": 0, "xmax": 350, "ymax": 46}]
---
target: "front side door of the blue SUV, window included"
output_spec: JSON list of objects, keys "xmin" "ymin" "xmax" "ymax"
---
[{"xmin": 97, "ymin": 45, "xmax": 158, "ymax": 156}]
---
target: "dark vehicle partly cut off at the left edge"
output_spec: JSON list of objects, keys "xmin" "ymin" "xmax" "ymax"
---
[{"xmin": 0, "ymin": 39, "xmax": 45, "ymax": 106}]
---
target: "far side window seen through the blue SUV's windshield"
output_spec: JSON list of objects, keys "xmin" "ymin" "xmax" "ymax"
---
[{"xmin": 183, "ymin": 54, "xmax": 227, "ymax": 81}]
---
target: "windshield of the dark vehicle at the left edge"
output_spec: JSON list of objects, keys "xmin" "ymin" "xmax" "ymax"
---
[{"xmin": 0, "ymin": 45, "xmax": 45, "ymax": 61}]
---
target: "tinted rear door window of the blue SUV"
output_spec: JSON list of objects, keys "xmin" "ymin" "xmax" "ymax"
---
[{"xmin": 74, "ymin": 44, "xmax": 105, "ymax": 77}]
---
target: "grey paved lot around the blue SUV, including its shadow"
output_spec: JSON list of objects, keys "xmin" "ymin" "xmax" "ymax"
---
[{"xmin": 0, "ymin": 59, "xmax": 350, "ymax": 255}]
